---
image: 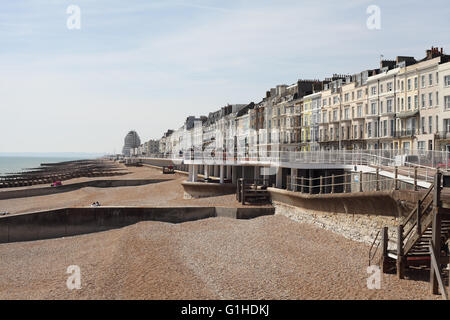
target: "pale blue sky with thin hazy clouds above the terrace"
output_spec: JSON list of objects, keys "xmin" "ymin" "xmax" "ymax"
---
[{"xmin": 0, "ymin": 0, "xmax": 450, "ymax": 153}]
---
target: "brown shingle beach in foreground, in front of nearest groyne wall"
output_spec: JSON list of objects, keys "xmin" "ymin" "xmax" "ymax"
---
[{"xmin": 0, "ymin": 215, "xmax": 440, "ymax": 299}]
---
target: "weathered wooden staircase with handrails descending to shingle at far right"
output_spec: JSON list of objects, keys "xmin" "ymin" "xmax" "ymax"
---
[{"xmin": 378, "ymin": 172, "xmax": 450, "ymax": 299}]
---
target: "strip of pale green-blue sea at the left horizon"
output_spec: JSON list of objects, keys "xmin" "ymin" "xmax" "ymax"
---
[{"xmin": 0, "ymin": 156, "xmax": 85, "ymax": 176}]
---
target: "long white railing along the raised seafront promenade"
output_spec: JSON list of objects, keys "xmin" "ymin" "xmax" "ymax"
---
[{"xmin": 143, "ymin": 148, "xmax": 450, "ymax": 182}]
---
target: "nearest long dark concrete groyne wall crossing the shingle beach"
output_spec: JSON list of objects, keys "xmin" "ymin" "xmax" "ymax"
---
[{"xmin": 0, "ymin": 207, "xmax": 275, "ymax": 243}]
